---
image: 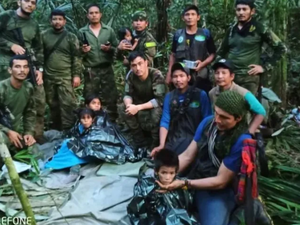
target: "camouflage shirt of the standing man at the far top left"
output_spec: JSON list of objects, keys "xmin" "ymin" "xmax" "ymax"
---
[{"xmin": 0, "ymin": 10, "xmax": 44, "ymax": 67}]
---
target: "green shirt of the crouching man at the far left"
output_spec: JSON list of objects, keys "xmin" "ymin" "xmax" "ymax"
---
[{"xmin": 0, "ymin": 78, "xmax": 36, "ymax": 135}]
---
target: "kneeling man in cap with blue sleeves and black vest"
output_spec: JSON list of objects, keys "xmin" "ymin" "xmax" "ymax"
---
[{"xmin": 151, "ymin": 63, "xmax": 212, "ymax": 156}]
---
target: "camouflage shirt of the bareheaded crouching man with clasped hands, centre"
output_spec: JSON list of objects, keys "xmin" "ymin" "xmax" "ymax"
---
[{"xmin": 124, "ymin": 68, "xmax": 166, "ymax": 108}]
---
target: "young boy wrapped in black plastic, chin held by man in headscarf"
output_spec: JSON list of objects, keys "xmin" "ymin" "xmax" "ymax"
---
[{"xmin": 127, "ymin": 149, "xmax": 197, "ymax": 225}]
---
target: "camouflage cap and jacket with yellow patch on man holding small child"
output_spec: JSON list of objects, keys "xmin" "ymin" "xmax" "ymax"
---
[{"xmin": 132, "ymin": 11, "xmax": 157, "ymax": 66}]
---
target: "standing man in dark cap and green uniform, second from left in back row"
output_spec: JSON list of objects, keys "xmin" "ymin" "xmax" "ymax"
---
[{"xmin": 42, "ymin": 10, "xmax": 82, "ymax": 130}]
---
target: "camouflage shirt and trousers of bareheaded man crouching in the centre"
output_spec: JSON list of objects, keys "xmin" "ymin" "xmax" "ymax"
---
[{"xmin": 122, "ymin": 68, "xmax": 166, "ymax": 148}]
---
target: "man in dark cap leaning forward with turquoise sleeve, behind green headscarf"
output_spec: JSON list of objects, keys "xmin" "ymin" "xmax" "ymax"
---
[{"xmin": 209, "ymin": 59, "xmax": 266, "ymax": 134}]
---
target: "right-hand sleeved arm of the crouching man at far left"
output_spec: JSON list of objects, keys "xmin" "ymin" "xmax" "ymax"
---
[{"xmin": 23, "ymin": 93, "xmax": 36, "ymax": 135}]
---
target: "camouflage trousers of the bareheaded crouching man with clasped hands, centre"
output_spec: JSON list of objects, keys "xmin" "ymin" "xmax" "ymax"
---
[{"xmin": 120, "ymin": 104, "xmax": 162, "ymax": 149}]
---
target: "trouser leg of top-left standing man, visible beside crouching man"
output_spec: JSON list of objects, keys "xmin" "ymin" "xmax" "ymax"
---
[{"xmin": 33, "ymin": 85, "xmax": 46, "ymax": 139}]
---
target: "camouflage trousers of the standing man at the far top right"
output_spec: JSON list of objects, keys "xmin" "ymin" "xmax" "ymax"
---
[{"xmin": 234, "ymin": 74, "xmax": 259, "ymax": 95}]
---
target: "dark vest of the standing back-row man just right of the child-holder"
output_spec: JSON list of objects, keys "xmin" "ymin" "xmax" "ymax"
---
[{"xmin": 175, "ymin": 28, "xmax": 208, "ymax": 62}]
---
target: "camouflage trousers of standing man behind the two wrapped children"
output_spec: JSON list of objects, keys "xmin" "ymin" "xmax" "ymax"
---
[{"xmin": 84, "ymin": 66, "xmax": 118, "ymax": 122}]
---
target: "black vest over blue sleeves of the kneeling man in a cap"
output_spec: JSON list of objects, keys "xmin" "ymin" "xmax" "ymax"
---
[{"xmin": 167, "ymin": 87, "xmax": 203, "ymax": 145}]
